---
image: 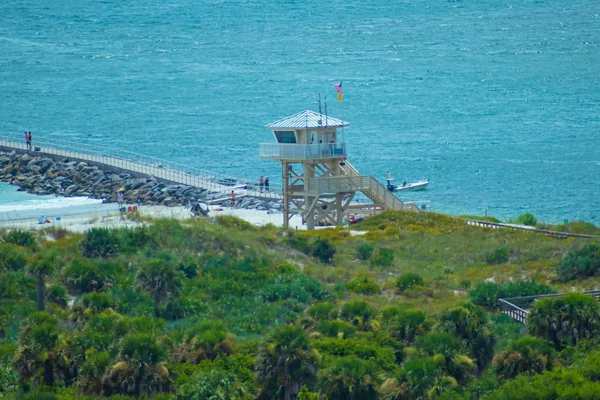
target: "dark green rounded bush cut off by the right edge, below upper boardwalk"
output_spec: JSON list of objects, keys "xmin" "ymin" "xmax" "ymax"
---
[{"xmin": 556, "ymin": 243, "xmax": 600, "ymax": 282}]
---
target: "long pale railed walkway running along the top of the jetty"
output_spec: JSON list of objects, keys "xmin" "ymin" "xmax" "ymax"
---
[{"xmin": 0, "ymin": 138, "xmax": 283, "ymax": 202}]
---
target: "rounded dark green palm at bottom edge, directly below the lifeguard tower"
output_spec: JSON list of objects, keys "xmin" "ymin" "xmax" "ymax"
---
[{"xmin": 255, "ymin": 325, "xmax": 320, "ymax": 400}]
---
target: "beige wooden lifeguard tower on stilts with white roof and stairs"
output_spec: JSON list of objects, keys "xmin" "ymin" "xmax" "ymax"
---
[{"xmin": 260, "ymin": 110, "xmax": 418, "ymax": 229}]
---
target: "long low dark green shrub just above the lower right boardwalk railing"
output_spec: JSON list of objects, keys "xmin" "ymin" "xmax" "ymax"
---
[{"xmin": 469, "ymin": 280, "xmax": 556, "ymax": 309}]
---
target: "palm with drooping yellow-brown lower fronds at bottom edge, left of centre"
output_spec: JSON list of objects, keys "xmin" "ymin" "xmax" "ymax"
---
[{"xmin": 102, "ymin": 334, "xmax": 173, "ymax": 397}]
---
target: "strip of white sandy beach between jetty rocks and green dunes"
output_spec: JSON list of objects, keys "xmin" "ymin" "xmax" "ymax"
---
[{"xmin": 0, "ymin": 204, "xmax": 306, "ymax": 233}]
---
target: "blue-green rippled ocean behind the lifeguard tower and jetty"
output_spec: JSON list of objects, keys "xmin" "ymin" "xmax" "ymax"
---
[{"xmin": 0, "ymin": 0, "xmax": 600, "ymax": 224}]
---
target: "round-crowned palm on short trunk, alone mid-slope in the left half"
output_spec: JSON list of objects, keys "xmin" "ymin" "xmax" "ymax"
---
[{"xmin": 136, "ymin": 259, "xmax": 181, "ymax": 317}]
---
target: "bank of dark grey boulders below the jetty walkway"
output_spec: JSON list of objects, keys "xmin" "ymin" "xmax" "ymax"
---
[{"xmin": 0, "ymin": 151, "xmax": 282, "ymax": 212}]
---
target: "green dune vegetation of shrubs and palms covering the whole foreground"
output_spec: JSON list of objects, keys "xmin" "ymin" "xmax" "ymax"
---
[{"xmin": 0, "ymin": 212, "xmax": 600, "ymax": 400}]
